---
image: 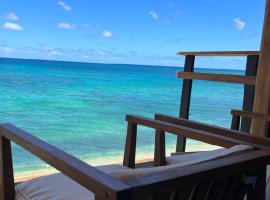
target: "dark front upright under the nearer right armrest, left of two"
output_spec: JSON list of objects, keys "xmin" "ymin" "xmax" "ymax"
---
[{"xmin": 123, "ymin": 122, "xmax": 137, "ymax": 168}]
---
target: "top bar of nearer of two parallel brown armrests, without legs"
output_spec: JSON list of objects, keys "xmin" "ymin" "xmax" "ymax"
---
[{"xmin": 126, "ymin": 115, "xmax": 258, "ymax": 147}]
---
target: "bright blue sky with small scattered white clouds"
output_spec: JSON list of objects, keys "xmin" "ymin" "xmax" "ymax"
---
[{"xmin": 0, "ymin": 0, "xmax": 265, "ymax": 69}]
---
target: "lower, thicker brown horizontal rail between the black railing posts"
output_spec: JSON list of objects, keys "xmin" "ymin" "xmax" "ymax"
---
[{"xmin": 176, "ymin": 71, "xmax": 256, "ymax": 85}]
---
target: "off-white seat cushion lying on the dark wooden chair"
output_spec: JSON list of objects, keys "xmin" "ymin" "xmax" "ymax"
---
[{"xmin": 16, "ymin": 145, "xmax": 252, "ymax": 200}]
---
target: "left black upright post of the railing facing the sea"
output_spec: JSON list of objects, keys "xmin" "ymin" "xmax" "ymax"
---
[{"xmin": 176, "ymin": 55, "xmax": 195, "ymax": 152}]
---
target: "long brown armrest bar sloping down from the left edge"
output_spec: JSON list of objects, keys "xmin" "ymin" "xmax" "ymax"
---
[{"xmin": 0, "ymin": 124, "xmax": 130, "ymax": 199}]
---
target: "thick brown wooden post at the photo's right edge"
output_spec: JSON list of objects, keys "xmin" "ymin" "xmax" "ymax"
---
[{"xmin": 251, "ymin": 0, "xmax": 270, "ymax": 136}]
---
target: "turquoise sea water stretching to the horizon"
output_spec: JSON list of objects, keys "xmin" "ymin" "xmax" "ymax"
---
[{"xmin": 0, "ymin": 59, "xmax": 243, "ymax": 173}]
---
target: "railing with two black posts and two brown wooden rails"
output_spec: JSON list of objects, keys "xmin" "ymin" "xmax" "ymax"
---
[{"xmin": 176, "ymin": 51, "xmax": 260, "ymax": 152}]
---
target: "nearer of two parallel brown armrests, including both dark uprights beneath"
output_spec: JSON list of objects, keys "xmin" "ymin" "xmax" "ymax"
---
[{"xmin": 123, "ymin": 115, "xmax": 260, "ymax": 168}]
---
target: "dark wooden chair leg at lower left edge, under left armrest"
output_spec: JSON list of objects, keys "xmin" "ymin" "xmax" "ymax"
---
[{"xmin": 0, "ymin": 136, "xmax": 15, "ymax": 200}]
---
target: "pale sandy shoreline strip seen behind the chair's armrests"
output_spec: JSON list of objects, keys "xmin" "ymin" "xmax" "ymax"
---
[{"xmin": 14, "ymin": 144, "xmax": 220, "ymax": 183}]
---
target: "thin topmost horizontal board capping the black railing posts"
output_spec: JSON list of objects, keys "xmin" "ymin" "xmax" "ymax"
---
[{"xmin": 177, "ymin": 51, "xmax": 260, "ymax": 56}]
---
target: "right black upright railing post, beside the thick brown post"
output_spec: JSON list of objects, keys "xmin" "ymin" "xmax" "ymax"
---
[{"xmin": 240, "ymin": 55, "xmax": 259, "ymax": 133}]
